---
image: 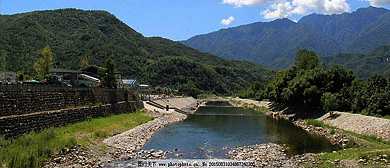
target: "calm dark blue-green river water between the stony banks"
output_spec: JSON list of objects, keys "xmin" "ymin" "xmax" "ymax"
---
[{"xmin": 142, "ymin": 102, "xmax": 339, "ymax": 159}]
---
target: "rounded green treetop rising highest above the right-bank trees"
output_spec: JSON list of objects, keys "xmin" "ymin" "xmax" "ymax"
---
[{"xmin": 295, "ymin": 49, "xmax": 319, "ymax": 70}]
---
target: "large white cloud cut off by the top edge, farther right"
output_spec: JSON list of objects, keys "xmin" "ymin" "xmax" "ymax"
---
[{"xmin": 292, "ymin": 0, "xmax": 351, "ymax": 15}]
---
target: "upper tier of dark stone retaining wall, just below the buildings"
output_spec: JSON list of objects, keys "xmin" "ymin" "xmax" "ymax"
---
[{"xmin": 0, "ymin": 91, "xmax": 125, "ymax": 117}]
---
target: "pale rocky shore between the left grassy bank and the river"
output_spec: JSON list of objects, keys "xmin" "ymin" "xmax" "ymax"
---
[{"xmin": 44, "ymin": 112, "xmax": 187, "ymax": 167}]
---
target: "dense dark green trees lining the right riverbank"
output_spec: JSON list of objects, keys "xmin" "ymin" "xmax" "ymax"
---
[{"xmin": 240, "ymin": 50, "xmax": 390, "ymax": 117}]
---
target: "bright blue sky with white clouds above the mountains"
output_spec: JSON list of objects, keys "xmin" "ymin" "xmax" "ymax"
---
[{"xmin": 0, "ymin": 0, "xmax": 390, "ymax": 41}]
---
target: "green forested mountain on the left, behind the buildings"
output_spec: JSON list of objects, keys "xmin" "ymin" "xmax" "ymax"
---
[{"xmin": 0, "ymin": 9, "xmax": 274, "ymax": 93}]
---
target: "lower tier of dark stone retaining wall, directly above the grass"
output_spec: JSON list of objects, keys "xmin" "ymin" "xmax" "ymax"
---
[{"xmin": 0, "ymin": 101, "xmax": 143, "ymax": 138}]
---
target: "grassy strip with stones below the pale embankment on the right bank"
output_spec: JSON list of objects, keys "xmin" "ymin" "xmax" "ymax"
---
[{"xmin": 305, "ymin": 119, "xmax": 390, "ymax": 167}]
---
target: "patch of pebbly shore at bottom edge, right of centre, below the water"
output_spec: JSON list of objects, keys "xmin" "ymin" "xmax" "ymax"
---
[{"xmin": 229, "ymin": 143, "xmax": 317, "ymax": 167}]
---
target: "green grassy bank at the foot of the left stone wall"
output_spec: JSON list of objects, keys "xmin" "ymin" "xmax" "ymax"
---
[{"xmin": 0, "ymin": 111, "xmax": 153, "ymax": 167}]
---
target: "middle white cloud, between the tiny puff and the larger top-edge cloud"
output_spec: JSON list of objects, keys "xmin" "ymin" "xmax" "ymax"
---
[{"xmin": 260, "ymin": 1, "xmax": 293, "ymax": 19}]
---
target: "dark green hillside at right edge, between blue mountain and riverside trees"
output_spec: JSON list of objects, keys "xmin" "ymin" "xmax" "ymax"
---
[{"xmin": 321, "ymin": 46, "xmax": 390, "ymax": 79}]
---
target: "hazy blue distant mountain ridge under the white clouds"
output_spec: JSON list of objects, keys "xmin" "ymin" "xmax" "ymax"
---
[{"xmin": 182, "ymin": 7, "xmax": 390, "ymax": 68}]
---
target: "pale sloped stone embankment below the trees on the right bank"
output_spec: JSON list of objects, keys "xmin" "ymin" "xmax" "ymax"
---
[{"xmin": 318, "ymin": 112, "xmax": 390, "ymax": 141}]
